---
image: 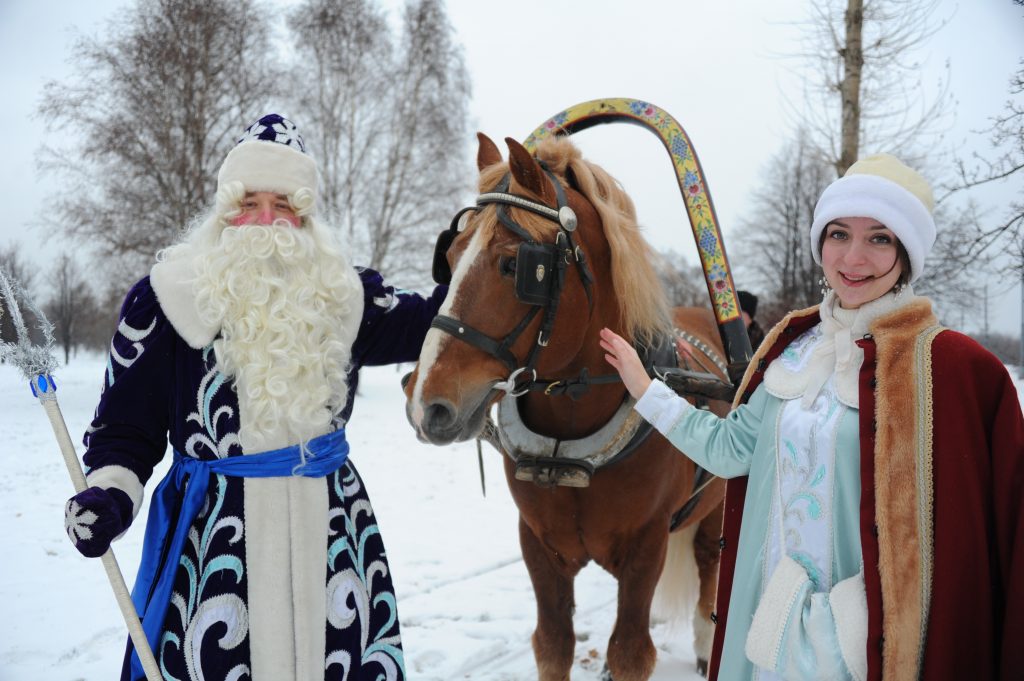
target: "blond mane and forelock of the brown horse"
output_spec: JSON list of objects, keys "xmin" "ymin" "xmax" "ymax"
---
[{"xmin": 480, "ymin": 137, "xmax": 672, "ymax": 345}]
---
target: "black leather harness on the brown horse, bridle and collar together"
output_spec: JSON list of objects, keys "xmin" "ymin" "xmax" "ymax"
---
[{"xmin": 430, "ymin": 162, "xmax": 714, "ymax": 520}]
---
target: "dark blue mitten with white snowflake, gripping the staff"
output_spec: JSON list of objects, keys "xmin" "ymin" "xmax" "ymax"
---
[{"xmin": 65, "ymin": 487, "xmax": 132, "ymax": 558}]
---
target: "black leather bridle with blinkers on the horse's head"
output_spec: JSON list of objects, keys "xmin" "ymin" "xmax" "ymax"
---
[{"xmin": 430, "ymin": 163, "xmax": 598, "ymax": 396}]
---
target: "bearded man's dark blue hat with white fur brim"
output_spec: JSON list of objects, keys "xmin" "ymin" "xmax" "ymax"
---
[{"xmin": 217, "ymin": 114, "xmax": 316, "ymax": 201}]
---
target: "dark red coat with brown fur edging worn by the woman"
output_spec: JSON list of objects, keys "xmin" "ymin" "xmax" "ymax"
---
[{"xmin": 710, "ymin": 299, "xmax": 1024, "ymax": 681}]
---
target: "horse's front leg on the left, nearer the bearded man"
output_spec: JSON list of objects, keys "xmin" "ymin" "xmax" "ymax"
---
[{"xmin": 519, "ymin": 517, "xmax": 575, "ymax": 681}]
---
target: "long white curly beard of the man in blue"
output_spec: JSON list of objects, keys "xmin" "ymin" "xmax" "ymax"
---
[{"xmin": 194, "ymin": 220, "xmax": 361, "ymax": 453}]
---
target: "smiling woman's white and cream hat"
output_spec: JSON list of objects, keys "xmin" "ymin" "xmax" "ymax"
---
[{"xmin": 810, "ymin": 154, "xmax": 935, "ymax": 282}]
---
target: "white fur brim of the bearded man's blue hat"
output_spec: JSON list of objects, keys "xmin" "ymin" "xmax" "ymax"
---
[{"xmin": 217, "ymin": 140, "xmax": 316, "ymax": 196}]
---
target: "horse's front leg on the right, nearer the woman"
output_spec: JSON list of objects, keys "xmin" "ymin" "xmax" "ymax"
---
[{"xmin": 608, "ymin": 522, "xmax": 669, "ymax": 681}]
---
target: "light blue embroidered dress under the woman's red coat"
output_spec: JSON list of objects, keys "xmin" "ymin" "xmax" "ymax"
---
[{"xmin": 636, "ymin": 326, "xmax": 866, "ymax": 681}]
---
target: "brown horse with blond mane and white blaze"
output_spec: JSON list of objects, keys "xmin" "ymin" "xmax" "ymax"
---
[{"xmin": 406, "ymin": 134, "xmax": 727, "ymax": 681}]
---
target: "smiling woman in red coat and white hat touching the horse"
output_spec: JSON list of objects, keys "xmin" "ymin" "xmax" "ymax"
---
[{"xmin": 602, "ymin": 155, "xmax": 1024, "ymax": 681}]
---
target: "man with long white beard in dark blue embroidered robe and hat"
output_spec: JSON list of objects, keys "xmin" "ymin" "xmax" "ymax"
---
[{"xmin": 66, "ymin": 115, "xmax": 445, "ymax": 681}]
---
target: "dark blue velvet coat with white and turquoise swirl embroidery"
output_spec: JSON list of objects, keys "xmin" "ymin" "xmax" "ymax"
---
[{"xmin": 84, "ymin": 269, "xmax": 446, "ymax": 681}]
